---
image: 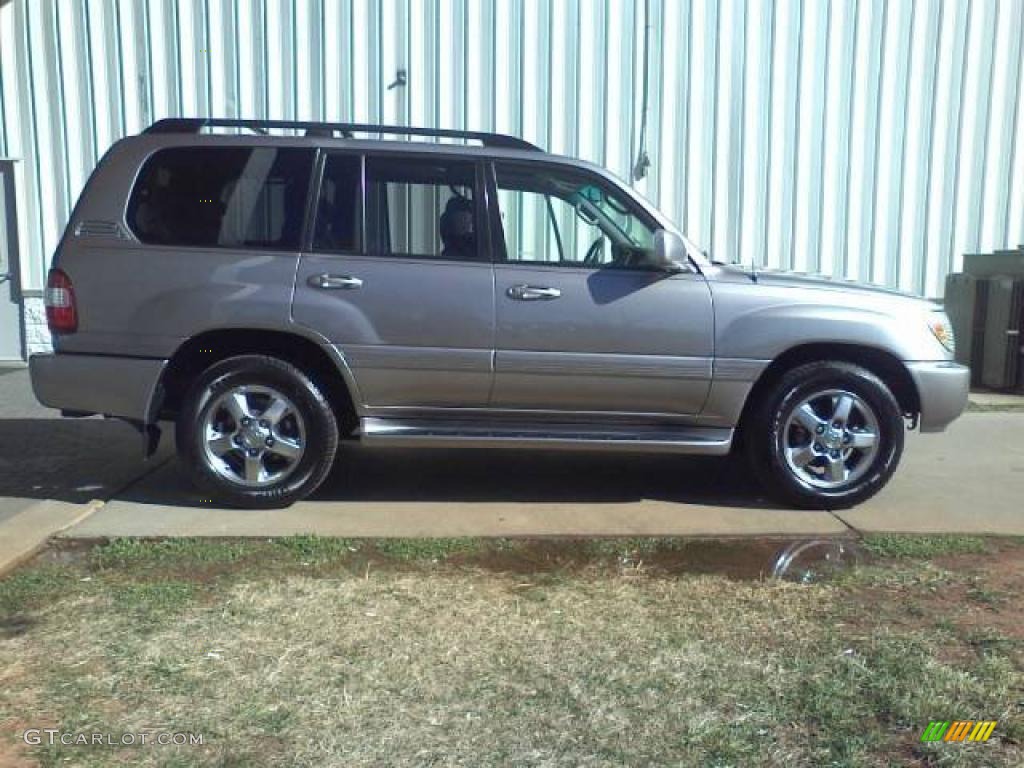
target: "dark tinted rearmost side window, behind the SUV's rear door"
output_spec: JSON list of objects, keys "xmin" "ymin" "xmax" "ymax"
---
[{"xmin": 128, "ymin": 146, "xmax": 313, "ymax": 251}]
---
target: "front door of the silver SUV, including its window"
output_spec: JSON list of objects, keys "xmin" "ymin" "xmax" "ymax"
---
[{"xmin": 492, "ymin": 163, "xmax": 714, "ymax": 415}]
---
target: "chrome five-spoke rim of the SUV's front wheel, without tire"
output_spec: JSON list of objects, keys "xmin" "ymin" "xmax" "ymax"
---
[{"xmin": 778, "ymin": 389, "xmax": 881, "ymax": 490}]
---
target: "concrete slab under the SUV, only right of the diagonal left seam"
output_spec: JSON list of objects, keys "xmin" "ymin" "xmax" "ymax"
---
[{"xmin": 66, "ymin": 413, "xmax": 1024, "ymax": 537}]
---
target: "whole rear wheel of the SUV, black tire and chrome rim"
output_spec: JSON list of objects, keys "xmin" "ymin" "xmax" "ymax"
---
[{"xmin": 175, "ymin": 355, "xmax": 338, "ymax": 509}]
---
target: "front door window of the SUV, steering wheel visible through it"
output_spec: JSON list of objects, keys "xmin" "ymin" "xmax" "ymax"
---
[{"xmin": 496, "ymin": 163, "xmax": 654, "ymax": 268}]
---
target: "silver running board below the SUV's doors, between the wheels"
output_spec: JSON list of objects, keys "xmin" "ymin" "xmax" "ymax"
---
[{"xmin": 359, "ymin": 417, "xmax": 732, "ymax": 456}]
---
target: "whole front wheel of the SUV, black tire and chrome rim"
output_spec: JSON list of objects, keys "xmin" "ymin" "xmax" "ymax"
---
[{"xmin": 744, "ymin": 361, "xmax": 904, "ymax": 509}]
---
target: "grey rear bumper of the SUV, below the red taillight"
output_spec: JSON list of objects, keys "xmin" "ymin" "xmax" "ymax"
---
[{"xmin": 29, "ymin": 354, "xmax": 167, "ymax": 424}]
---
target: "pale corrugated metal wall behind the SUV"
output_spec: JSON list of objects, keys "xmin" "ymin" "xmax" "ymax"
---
[{"xmin": 0, "ymin": 0, "xmax": 1024, "ymax": 296}]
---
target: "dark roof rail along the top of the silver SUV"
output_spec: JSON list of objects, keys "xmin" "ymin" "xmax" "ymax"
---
[{"xmin": 142, "ymin": 118, "xmax": 542, "ymax": 152}]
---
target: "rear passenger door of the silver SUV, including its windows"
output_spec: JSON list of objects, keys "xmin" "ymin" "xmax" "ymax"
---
[{"xmin": 293, "ymin": 153, "xmax": 495, "ymax": 415}]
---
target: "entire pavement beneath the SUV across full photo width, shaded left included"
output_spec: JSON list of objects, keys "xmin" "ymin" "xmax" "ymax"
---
[{"xmin": 0, "ymin": 371, "xmax": 1024, "ymax": 568}]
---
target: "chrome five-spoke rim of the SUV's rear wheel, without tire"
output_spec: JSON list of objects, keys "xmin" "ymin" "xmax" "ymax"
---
[{"xmin": 202, "ymin": 386, "xmax": 306, "ymax": 487}]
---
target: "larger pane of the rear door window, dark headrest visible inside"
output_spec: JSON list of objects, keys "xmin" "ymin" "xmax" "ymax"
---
[{"xmin": 367, "ymin": 158, "xmax": 481, "ymax": 259}]
